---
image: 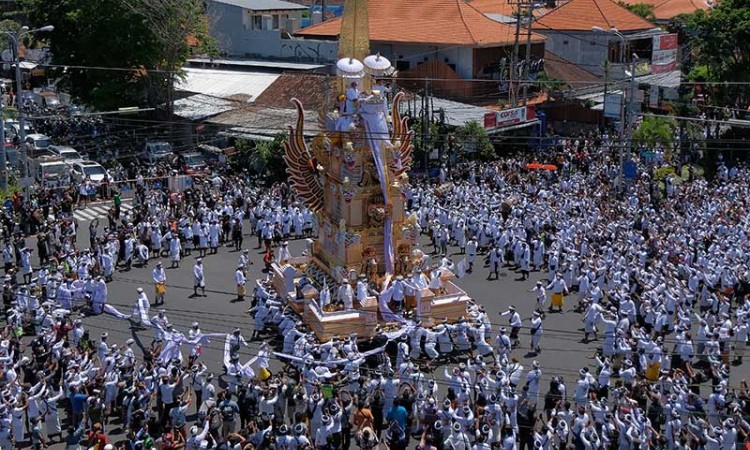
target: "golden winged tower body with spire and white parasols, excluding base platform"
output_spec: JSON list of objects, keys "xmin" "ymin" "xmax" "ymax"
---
[{"xmin": 285, "ymin": 0, "xmax": 412, "ymax": 281}]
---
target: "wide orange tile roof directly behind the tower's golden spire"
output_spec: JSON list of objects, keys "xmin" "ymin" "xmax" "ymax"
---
[{"xmin": 296, "ymin": 0, "xmax": 545, "ymax": 47}]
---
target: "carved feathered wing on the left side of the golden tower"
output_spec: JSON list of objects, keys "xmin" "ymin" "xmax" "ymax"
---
[{"xmin": 284, "ymin": 98, "xmax": 324, "ymax": 212}]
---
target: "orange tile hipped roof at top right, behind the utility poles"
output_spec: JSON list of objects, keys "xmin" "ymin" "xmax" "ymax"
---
[{"xmin": 534, "ymin": 0, "xmax": 654, "ymax": 32}]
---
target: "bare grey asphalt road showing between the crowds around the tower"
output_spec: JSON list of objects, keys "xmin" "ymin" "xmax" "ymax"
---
[{"xmin": 30, "ymin": 204, "xmax": 748, "ymax": 449}]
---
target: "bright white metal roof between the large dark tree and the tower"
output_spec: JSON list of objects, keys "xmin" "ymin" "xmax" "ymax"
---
[{"xmin": 177, "ymin": 68, "xmax": 279, "ymax": 102}]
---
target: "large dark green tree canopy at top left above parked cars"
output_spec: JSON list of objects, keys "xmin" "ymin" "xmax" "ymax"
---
[{"xmin": 24, "ymin": 0, "xmax": 210, "ymax": 110}]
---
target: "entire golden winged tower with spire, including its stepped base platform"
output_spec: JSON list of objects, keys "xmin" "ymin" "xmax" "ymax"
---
[{"xmin": 272, "ymin": 0, "xmax": 470, "ymax": 340}]
